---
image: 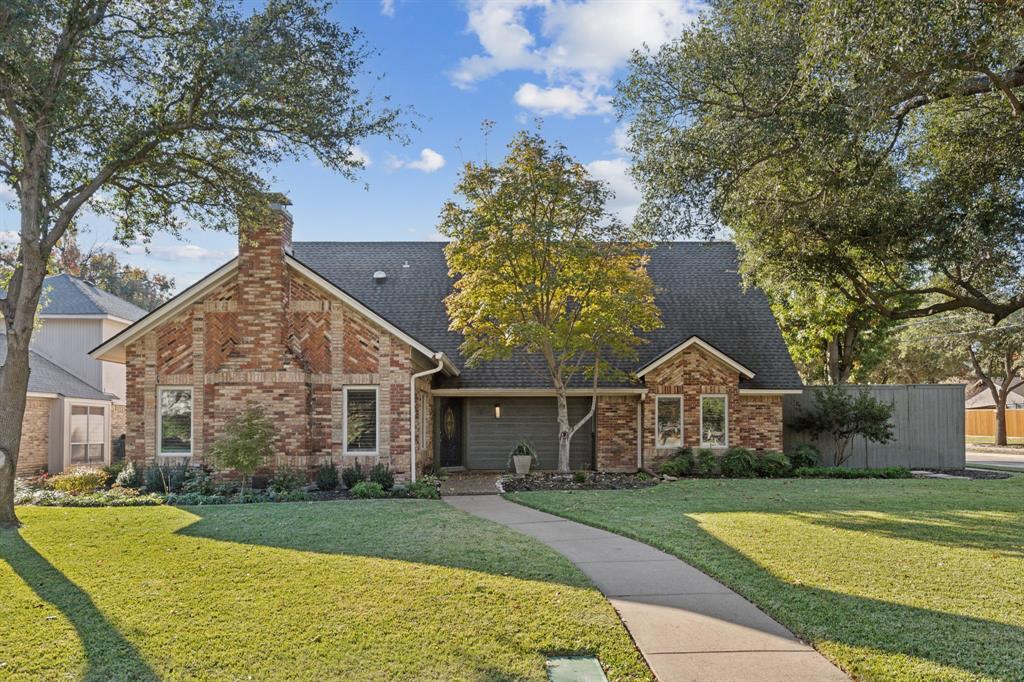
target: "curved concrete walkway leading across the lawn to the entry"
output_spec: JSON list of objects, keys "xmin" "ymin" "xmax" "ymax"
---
[{"xmin": 444, "ymin": 496, "xmax": 849, "ymax": 682}]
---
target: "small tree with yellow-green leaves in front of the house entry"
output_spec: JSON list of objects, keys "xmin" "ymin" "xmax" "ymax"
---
[{"xmin": 439, "ymin": 132, "xmax": 660, "ymax": 471}]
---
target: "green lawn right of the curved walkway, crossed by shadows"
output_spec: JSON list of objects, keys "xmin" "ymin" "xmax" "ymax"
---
[{"xmin": 509, "ymin": 476, "xmax": 1024, "ymax": 681}]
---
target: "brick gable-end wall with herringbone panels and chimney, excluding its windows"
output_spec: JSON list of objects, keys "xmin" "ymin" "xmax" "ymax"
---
[{"xmin": 126, "ymin": 201, "xmax": 431, "ymax": 479}]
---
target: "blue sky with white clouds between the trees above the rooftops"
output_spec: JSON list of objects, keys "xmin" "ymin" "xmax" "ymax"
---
[{"xmin": 0, "ymin": 0, "xmax": 697, "ymax": 290}]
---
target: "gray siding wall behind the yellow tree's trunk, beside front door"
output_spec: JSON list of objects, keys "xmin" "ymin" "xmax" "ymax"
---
[{"xmin": 465, "ymin": 397, "xmax": 593, "ymax": 469}]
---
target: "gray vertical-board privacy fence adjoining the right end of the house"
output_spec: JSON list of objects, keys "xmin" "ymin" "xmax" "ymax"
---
[{"xmin": 782, "ymin": 384, "xmax": 966, "ymax": 469}]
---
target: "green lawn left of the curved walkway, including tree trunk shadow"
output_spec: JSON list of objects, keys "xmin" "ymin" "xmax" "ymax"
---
[{"xmin": 0, "ymin": 500, "xmax": 650, "ymax": 680}]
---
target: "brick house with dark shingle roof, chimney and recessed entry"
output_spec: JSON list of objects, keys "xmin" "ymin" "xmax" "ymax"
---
[{"xmin": 92, "ymin": 197, "xmax": 802, "ymax": 478}]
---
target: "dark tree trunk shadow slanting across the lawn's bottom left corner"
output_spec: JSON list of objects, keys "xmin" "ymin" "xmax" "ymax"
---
[{"xmin": 0, "ymin": 530, "xmax": 159, "ymax": 681}]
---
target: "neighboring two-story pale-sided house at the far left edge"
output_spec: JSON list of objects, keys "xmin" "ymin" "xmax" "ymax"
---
[{"xmin": 6, "ymin": 274, "xmax": 145, "ymax": 476}]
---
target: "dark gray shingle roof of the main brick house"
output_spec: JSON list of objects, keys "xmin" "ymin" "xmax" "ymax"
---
[{"xmin": 294, "ymin": 242, "xmax": 802, "ymax": 389}]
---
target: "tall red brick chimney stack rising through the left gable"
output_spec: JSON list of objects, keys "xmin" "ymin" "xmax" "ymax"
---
[{"xmin": 237, "ymin": 193, "xmax": 292, "ymax": 372}]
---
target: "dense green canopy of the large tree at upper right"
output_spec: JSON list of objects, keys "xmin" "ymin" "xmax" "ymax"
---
[{"xmin": 616, "ymin": 0, "xmax": 1024, "ymax": 322}]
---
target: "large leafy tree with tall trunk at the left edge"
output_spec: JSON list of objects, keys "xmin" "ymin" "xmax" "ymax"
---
[{"xmin": 0, "ymin": 0, "xmax": 400, "ymax": 525}]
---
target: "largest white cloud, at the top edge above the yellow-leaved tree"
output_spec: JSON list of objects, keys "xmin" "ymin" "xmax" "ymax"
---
[{"xmin": 451, "ymin": 0, "xmax": 698, "ymax": 116}]
